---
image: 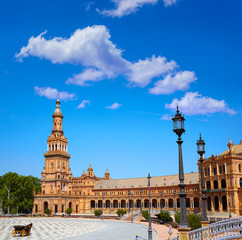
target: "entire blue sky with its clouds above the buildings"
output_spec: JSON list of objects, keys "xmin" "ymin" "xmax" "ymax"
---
[{"xmin": 0, "ymin": 0, "xmax": 242, "ymax": 178}]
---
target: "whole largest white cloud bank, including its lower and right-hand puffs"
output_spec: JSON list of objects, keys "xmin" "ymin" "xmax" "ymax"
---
[{"xmin": 15, "ymin": 25, "xmax": 196, "ymax": 94}]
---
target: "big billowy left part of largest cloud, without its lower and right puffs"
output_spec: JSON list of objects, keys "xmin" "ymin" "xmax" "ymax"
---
[{"xmin": 15, "ymin": 25, "xmax": 129, "ymax": 78}]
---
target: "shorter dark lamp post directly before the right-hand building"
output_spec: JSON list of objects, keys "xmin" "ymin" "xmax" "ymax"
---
[{"xmin": 197, "ymin": 134, "xmax": 208, "ymax": 222}]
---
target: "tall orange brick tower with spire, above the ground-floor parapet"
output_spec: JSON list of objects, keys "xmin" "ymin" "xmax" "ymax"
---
[{"xmin": 41, "ymin": 98, "xmax": 72, "ymax": 195}]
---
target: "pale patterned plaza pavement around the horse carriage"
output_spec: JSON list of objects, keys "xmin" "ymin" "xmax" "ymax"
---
[{"xmin": 0, "ymin": 218, "xmax": 158, "ymax": 240}]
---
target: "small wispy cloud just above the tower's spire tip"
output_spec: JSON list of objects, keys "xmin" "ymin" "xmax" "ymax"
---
[{"xmin": 34, "ymin": 86, "xmax": 76, "ymax": 101}]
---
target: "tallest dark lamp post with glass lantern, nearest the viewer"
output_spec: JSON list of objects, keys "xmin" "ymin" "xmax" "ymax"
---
[{"xmin": 172, "ymin": 106, "xmax": 188, "ymax": 228}]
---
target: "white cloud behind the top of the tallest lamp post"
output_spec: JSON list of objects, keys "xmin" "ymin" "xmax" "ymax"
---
[{"xmin": 165, "ymin": 92, "xmax": 236, "ymax": 115}]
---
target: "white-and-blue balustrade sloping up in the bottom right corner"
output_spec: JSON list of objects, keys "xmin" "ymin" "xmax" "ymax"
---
[{"xmin": 189, "ymin": 217, "xmax": 242, "ymax": 240}]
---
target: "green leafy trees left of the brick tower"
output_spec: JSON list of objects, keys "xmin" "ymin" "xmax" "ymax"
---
[{"xmin": 0, "ymin": 172, "xmax": 41, "ymax": 214}]
